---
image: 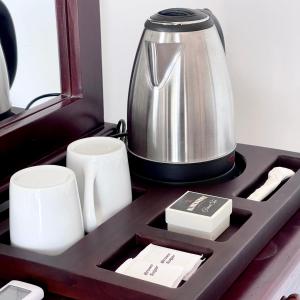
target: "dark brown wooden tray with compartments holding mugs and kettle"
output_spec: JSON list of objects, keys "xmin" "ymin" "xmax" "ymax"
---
[{"xmin": 0, "ymin": 145, "xmax": 300, "ymax": 300}]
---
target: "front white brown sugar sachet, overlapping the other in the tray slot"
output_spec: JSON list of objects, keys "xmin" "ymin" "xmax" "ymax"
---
[{"xmin": 116, "ymin": 258, "xmax": 184, "ymax": 288}]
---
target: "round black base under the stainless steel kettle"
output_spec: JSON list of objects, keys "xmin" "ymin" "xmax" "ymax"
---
[{"xmin": 128, "ymin": 151, "xmax": 246, "ymax": 185}]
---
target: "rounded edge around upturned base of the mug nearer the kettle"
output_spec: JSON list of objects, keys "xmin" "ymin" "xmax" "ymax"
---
[{"xmin": 67, "ymin": 136, "xmax": 125, "ymax": 157}]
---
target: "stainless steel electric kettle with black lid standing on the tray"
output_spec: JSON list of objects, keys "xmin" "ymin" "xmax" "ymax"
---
[{"xmin": 127, "ymin": 8, "xmax": 236, "ymax": 183}]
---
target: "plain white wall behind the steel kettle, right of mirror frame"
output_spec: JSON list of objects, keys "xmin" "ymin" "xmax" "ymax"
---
[{"xmin": 101, "ymin": 0, "xmax": 300, "ymax": 151}]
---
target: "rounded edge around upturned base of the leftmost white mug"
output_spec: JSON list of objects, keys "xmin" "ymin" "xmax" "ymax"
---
[{"xmin": 10, "ymin": 165, "xmax": 76, "ymax": 190}]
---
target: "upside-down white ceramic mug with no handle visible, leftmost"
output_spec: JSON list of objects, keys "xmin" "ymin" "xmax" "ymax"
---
[{"xmin": 9, "ymin": 165, "xmax": 84, "ymax": 255}]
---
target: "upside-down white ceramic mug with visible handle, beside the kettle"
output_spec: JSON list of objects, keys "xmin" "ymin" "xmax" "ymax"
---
[{"xmin": 67, "ymin": 137, "xmax": 132, "ymax": 232}]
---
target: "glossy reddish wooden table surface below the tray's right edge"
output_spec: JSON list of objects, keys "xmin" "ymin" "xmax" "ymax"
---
[{"xmin": 222, "ymin": 210, "xmax": 300, "ymax": 300}]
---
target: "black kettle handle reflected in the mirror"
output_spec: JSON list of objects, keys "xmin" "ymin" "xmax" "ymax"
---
[{"xmin": 0, "ymin": 0, "xmax": 18, "ymax": 86}]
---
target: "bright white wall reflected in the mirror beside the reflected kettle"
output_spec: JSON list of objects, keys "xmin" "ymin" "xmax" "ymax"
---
[{"xmin": 0, "ymin": 0, "xmax": 61, "ymax": 118}]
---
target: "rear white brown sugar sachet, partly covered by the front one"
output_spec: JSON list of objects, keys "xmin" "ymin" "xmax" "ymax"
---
[{"xmin": 136, "ymin": 244, "xmax": 205, "ymax": 281}]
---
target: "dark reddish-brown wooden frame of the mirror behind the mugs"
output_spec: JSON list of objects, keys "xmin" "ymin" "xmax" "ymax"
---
[{"xmin": 0, "ymin": 0, "xmax": 112, "ymax": 188}]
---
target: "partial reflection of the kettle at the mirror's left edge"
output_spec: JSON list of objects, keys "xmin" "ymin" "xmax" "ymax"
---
[{"xmin": 0, "ymin": 1, "xmax": 17, "ymax": 119}]
